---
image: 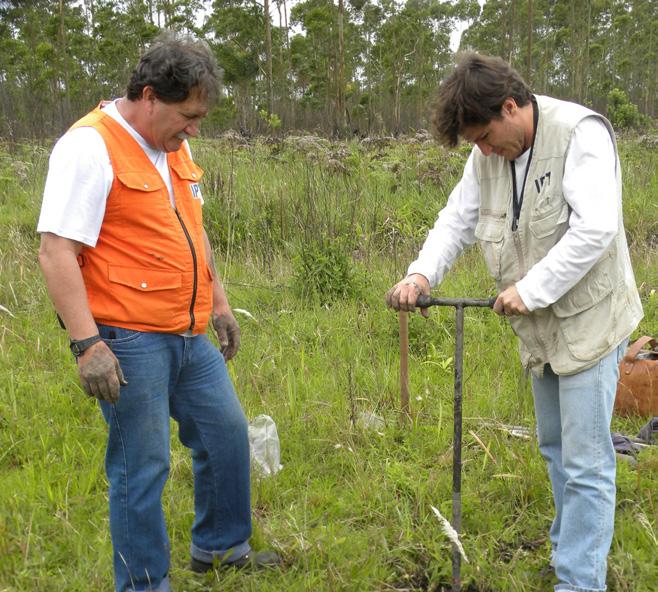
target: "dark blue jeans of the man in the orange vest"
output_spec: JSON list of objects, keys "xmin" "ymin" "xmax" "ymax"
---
[{"xmin": 99, "ymin": 325, "xmax": 251, "ymax": 592}]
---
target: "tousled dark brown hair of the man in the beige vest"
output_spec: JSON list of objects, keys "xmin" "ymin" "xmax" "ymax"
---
[{"xmin": 432, "ymin": 51, "xmax": 532, "ymax": 147}]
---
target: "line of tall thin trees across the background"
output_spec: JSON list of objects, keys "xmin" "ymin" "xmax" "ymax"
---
[{"xmin": 0, "ymin": 0, "xmax": 658, "ymax": 138}]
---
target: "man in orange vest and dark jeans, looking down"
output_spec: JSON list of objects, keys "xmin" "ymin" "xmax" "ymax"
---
[{"xmin": 38, "ymin": 35, "xmax": 280, "ymax": 592}]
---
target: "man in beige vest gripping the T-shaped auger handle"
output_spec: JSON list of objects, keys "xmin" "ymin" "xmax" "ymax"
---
[{"xmin": 386, "ymin": 53, "xmax": 642, "ymax": 592}]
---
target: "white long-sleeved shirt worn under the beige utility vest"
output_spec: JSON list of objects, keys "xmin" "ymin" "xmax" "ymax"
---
[{"xmin": 408, "ymin": 117, "xmax": 619, "ymax": 311}]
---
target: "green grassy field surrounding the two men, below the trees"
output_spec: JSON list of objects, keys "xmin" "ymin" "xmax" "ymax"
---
[{"xmin": 0, "ymin": 135, "xmax": 658, "ymax": 592}]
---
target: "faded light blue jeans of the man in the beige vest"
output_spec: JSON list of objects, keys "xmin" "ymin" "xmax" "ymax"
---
[{"xmin": 532, "ymin": 341, "xmax": 626, "ymax": 592}]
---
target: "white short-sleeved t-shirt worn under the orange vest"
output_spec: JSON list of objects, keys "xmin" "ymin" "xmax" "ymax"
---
[{"xmin": 37, "ymin": 101, "xmax": 188, "ymax": 247}]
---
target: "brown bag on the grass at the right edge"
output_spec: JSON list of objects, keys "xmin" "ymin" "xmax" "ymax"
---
[{"xmin": 615, "ymin": 335, "xmax": 658, "ymax": 416}]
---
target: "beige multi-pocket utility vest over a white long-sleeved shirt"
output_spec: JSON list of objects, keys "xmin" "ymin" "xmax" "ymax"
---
[{"xmin": 475, "ymin": 96, "xmax": 642, "ymax": 374}]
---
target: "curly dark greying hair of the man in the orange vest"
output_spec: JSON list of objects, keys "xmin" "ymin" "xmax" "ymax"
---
[{"xmin": 126, "ymin": 32, "xmax": 221, "ymax": 103}]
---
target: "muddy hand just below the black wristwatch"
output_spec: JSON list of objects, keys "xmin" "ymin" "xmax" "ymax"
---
[{"xmin": 78, "ymin": 341, "xmax": 128, "ymax": 404}]
